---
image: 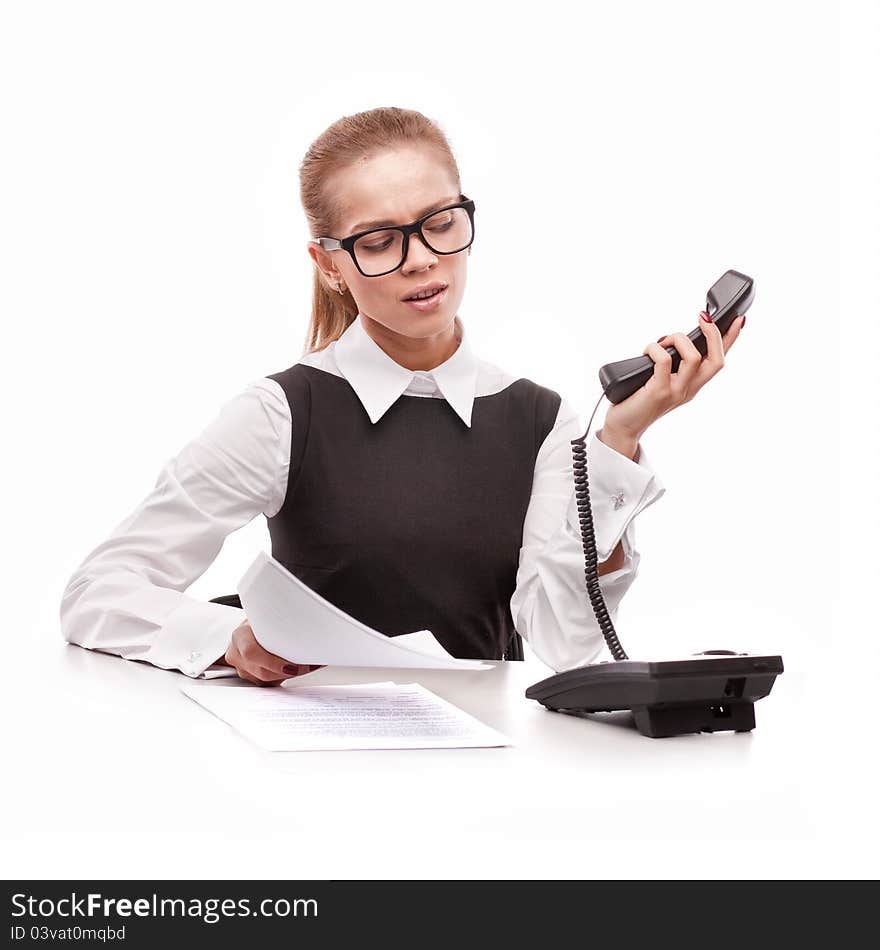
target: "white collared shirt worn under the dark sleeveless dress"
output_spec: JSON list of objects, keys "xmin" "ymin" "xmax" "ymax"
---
[{"xmin": 60, "ymin": 316, "xmax": 665, "ymax": 677}]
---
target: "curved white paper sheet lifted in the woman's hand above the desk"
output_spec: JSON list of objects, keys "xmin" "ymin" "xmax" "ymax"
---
[{"xmin": 238, "ymin": 551, "xmax": 491, "ymax": 670}]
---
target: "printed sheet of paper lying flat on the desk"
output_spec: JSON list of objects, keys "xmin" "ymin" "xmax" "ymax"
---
[{"xmin": 181, "ymin": 682, "xmax": 511, "ymax": 752}]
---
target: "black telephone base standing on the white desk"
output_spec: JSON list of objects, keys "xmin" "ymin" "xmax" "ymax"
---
[{"xmin": 526, "ymin": 651, "xmax": 783, "ymax": 739}]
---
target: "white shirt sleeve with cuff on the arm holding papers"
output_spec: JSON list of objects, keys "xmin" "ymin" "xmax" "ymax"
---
[{"xmin": 60, "ymin": 378, "xmax": 291, "ymax": 677}]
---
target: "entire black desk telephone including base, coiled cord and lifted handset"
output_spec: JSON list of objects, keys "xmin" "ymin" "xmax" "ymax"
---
[{"xmin": 526, "ymin": 270, "xmax": 783, "ymax": 738}]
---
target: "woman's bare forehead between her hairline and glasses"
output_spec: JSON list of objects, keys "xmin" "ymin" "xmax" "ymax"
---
[{"xmin": 330, "ymin": 148, "xmax": 458, "ymax": 234}]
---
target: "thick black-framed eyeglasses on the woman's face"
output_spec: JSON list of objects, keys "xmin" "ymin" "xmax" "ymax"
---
[{"xmin": 312, "ymin": 195, "xmax": 474, "ymax": 277}]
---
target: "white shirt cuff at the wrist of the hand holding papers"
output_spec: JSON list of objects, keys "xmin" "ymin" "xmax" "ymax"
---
[{"xmin": 144, "ymin": 599, "xmax": 246, "ymax": 679}]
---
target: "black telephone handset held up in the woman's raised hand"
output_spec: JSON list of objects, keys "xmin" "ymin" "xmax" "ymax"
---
[{"xmin": 599, "ymin": 270, "xmax": 755, "ymax": 403}]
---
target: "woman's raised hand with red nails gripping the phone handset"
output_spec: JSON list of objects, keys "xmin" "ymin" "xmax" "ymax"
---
[{"xmin": 603, "ymin": 310, "xmax": 746, "ymax": 442}]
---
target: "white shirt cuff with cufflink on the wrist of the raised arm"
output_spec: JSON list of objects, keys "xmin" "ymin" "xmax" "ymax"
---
[{"xmin": 566, "ymin": 433, "xmax": 666, "ymax": 563}]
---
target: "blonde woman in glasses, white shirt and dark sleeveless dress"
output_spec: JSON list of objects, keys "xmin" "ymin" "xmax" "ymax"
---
[{"xmin": 61, "ymin": 108, "xmax": 745, "ymax": 685}]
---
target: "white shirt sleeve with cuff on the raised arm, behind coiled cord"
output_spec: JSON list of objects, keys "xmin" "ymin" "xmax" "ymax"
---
[{"xmin": 510, "ymin": 400, "xmax": 666, "ymax": 672}]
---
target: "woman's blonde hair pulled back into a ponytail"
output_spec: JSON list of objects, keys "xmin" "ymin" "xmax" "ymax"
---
[{"xmin": 299, "ymin": 106, "xmax": 461, "ymax": 353}]
